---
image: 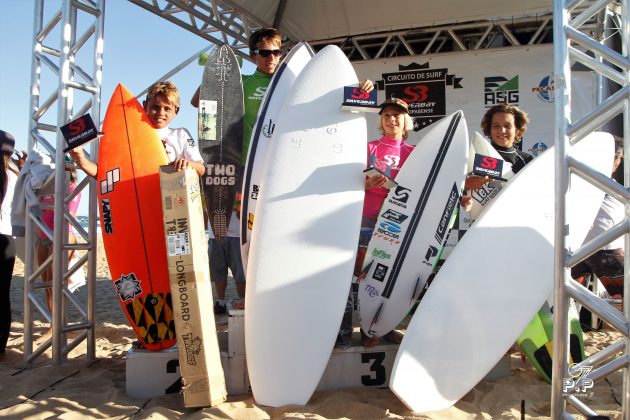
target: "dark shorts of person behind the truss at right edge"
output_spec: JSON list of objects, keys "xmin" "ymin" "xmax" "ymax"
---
[{"xmin": 571, "ymin": 248, "xmax": 624, "ymax": 296}]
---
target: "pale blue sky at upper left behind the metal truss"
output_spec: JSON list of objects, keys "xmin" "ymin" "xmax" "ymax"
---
[{"xmin": 0, "ymin": 0, "xmax": 254, "ymax": 214}]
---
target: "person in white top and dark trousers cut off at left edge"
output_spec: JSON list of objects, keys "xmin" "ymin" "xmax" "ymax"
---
[{"xmin": 0, "ymin": 130, "xmax": 18, "ymax": 354}]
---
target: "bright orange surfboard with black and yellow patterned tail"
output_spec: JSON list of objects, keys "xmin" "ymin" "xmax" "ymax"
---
[{"xmin": 96, "ymin": 84, "xmax": 176, "ymax": 350}]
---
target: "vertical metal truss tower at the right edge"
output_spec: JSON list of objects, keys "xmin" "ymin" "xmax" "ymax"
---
[{"xmin": 551, "ymin": 0, "xmax": 630, "ymax": 419}]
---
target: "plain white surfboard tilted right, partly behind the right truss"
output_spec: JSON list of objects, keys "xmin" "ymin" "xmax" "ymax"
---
[{"xmin": 390, "ymin": 133, "xmax": 614, "ymax": 412}]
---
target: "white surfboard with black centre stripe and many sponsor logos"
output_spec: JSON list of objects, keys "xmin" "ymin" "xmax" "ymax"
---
[{"xmin": 359, "ymin": 111, "xmax": 468, "ymax": 337}]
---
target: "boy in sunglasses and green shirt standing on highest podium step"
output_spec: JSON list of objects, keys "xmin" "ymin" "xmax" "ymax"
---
[{"xmin": 190, "ymin": 28, "xmax": 282, "ymax": 314}]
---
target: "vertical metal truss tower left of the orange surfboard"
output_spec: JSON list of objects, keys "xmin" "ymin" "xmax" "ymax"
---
[{"xmin": 24, "ymin": 0, "xmax": 104, "ymax": 366}]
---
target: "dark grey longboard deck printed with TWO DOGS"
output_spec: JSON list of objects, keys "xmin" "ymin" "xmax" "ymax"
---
[{"xmin": 198, "ymin": 44, "xmax": 244, "ymax": 240}]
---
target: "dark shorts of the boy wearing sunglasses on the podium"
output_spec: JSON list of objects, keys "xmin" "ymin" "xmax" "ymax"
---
[{"xmin": 208, "ymin": 237, "xmax": 245, "ymax": 283}]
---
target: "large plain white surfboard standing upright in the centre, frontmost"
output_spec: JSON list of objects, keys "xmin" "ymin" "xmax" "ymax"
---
[{"xmin": 245, "ymin": 46, "xmax": 367, "ymax": 407}]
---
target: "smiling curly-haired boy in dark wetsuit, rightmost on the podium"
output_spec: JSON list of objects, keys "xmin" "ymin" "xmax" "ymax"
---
[{"xmin": 465, "ymin": 104, "xmax": 533, "ymax": 191}]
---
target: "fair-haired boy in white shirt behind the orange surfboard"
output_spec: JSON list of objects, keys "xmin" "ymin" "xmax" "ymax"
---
[{"xmin": 68, "ymin": 80, "xmax": 206, "ymax": 178}]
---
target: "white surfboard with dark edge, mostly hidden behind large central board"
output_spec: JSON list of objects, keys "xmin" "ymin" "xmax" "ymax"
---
[{"xmin": 240, "ymin": 42, "xmax": 315, "ymax": 272}]
